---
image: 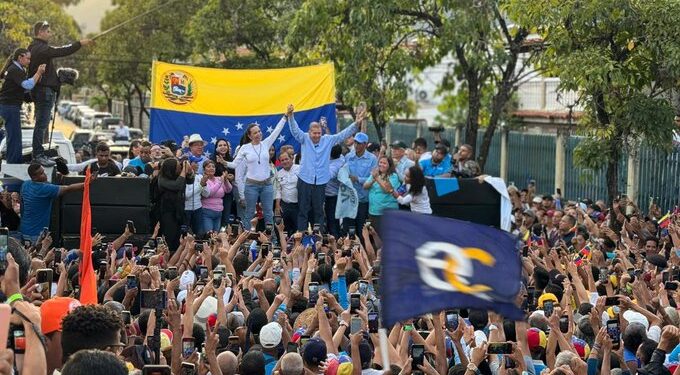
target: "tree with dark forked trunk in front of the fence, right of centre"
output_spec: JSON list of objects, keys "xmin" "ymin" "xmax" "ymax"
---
[{"xmin": 390, "ymin": 0, "xmax": 537, "ymax": 170}]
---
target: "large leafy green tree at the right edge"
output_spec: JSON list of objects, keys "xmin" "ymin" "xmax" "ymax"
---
[{"xmin": 508, "ymin": 0, "xmax": 680, "ymax": 203}]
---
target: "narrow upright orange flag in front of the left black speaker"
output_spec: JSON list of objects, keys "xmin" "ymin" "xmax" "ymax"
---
[{"xmin": 80, "ymin": 168, "xmax": 97, "ymax": 305}]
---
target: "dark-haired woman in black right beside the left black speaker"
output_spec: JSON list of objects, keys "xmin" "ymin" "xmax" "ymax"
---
[{"xmin": 158, "ymin": 158, "xmax": 191, "ymax": 252}]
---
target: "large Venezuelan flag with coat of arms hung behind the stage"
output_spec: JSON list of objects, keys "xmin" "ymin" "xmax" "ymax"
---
[{"xmin": 149, "ymin": 61, "xmax": 336, "ymax": 151}]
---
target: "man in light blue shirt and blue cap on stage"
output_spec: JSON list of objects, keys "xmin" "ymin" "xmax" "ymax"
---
[{"xmin": 342, "ymin": 133, "xmax": 378, "ymax": 237}]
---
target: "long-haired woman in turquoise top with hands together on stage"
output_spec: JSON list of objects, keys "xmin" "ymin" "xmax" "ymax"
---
[{"xmin": 364, "ymin": 156, "xmax": 399, "ymax": 230}]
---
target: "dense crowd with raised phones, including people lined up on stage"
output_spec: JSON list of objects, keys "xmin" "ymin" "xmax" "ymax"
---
[{"xmin": 0, "ymin": 17, "xmax": 680, "ymax": 375}]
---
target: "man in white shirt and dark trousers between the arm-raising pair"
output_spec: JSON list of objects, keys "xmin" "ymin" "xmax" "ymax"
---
[{"xmin": 274, "ymin": 152, "xmax": 300, "ymax": 233}]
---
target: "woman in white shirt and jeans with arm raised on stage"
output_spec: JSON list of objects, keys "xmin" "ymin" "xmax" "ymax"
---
[{"xmin": 234, "ymin": 107, "xmax": 291, "ymax": 229}]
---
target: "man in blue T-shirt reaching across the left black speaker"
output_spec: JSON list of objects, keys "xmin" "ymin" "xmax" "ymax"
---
[{"xmin": 19, "ymin": 163, "xmax": 90, "ymax": 242}]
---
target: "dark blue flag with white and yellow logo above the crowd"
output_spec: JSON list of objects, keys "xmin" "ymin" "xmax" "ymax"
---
[{"xmin": 380, "ymin": 211, "xmax": 523, "ymax": 327}]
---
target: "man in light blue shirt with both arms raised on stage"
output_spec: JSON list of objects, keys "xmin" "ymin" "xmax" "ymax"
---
[{"xmin": 288, "ymin": 105, "xmax": 364, "ymax": 231}]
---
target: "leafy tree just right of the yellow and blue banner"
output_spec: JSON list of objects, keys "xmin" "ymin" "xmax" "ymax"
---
[{"xmin": 287, "ymin": 0, "xmax": 434, "ymax": 139}]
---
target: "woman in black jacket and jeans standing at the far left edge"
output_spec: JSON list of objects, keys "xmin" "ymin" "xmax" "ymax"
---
[{"xmin": 0, "ymin": 48, "xmax": 45, "ymax": 164}]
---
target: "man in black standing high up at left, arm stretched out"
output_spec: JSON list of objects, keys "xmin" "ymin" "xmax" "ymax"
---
[{"xmin": 28, "ymin": 21, "xmax": 92, "ymax": 167}]
